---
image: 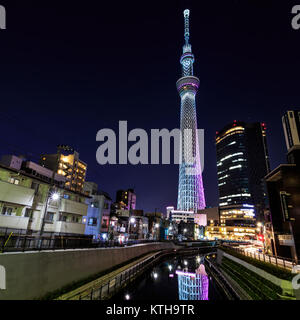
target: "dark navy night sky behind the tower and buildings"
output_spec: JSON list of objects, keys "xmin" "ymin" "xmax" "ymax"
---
[{"xmin": 0, "ymin": 0, "xmax": 300, "ymax": 211}]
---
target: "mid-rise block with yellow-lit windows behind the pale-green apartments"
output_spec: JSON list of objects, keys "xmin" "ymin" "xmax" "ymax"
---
[{"xmin": 40, "ymin": 151, "xmax": 87, "ymax": 192}]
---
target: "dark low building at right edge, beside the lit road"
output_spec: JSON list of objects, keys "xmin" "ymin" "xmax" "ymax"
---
[{"xmin": 265, "ymin": 146, "xmax": 300, "ymax": 262}]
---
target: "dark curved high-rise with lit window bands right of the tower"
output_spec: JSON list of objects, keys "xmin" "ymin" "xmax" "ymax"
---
[{"xmin": 216, "ymin": 121, "xmax": 270, "ymax": 237}]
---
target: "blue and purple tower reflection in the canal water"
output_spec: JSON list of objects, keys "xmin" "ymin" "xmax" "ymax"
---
[{"xmin": 176, "ymin": 261, "xmax": 209, "ymax": 300}]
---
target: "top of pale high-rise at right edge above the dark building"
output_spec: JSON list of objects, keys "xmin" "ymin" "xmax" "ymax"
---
[{"xmin": 282, "ymin": 111, "xmax": 300, "ymax": 150}]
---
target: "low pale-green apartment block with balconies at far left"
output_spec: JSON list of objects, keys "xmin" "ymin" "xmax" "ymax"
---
[{"xmin": 0, "ymin": 156, "xmax": 87, "ymax": 236}]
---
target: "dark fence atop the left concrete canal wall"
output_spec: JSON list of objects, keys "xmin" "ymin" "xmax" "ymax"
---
[{"xmin": 0, "ymin": 232, "xmax": 157, "ymax": 253}]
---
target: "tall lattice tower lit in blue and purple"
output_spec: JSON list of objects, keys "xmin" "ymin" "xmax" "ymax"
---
[{"xmin": 176, "ymin": 10, "xmax": 205, "ymax": 212}]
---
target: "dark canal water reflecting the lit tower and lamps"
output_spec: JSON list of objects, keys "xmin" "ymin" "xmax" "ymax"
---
[{"xmin": 112, "ymin": 254, "xmax": 226, "ymax": 301}]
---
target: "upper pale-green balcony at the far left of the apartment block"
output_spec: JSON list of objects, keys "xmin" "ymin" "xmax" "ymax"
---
[{"xmin": 0, "ymin": 181, "xmax": 34, "ymax": 206}]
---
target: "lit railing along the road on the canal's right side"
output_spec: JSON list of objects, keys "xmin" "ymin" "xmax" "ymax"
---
[{"xmin": 223, "ymin": 244, "xmax": 297, "ymax": 271}]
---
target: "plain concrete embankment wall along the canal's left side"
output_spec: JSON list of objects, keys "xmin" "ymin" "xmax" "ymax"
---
[{"xmin": 0, "ymin": 242, "xmax": 175, "ymax": 300}]
